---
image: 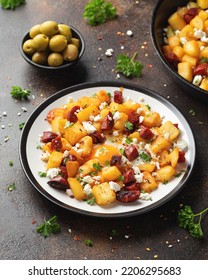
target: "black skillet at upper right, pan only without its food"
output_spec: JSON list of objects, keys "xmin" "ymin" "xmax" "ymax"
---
[{"xmin": 151, "ymin": 0, "xmax": 208, "ymax": 103}]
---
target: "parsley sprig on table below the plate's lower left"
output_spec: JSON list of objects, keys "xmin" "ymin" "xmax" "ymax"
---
[{"xmin": 36, "ymin": 216, "xmax": 61, "ymax": 237}]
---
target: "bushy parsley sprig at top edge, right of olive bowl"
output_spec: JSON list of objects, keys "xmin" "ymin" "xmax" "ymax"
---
[{"xmin": 83, "ymin": 0, "xmax": 116, "ymax": 26}]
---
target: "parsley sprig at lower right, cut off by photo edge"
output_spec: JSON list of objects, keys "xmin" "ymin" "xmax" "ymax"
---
[{"xmin": 178, "ymin": 205, "xmax": 208, "ymax": 239}]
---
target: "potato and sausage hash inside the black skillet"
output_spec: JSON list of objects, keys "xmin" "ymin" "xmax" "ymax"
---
[{"xmin": 163, "ymin": 0, "xmax": 208, "ymax": 90}]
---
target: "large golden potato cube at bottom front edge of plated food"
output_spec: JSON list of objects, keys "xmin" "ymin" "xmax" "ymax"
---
[{"xmin": 92, "ymin": 182, "xmax": 116, "ymax": 205}]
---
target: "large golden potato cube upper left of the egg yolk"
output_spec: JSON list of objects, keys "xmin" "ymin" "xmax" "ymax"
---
[{"xmin": 64, "ymin": 122, "xmax": 87, "ymax": 146}]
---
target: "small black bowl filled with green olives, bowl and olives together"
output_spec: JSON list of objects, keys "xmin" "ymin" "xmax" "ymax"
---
[{"xmin": 20, "ymin": 21, "xmax": 85, "ymax": 70}]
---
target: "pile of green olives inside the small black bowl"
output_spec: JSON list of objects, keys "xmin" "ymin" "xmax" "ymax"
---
[{"xmin": 22, "ymin": 21, "xmax": 80, "ymax": 67}]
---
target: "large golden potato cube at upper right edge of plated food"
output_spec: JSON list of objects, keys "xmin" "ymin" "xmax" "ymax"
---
[{"xmin": 158, "ymin": 121, "xmax": 180, "ymax": 142}]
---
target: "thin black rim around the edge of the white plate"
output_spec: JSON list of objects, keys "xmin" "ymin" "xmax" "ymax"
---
[{"xmin": 19, "ymin": 81, "xmax": 196, "ymax": 218}]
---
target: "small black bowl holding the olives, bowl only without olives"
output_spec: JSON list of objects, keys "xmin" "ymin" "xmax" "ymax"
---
[{"xmin": 20, "ymin": 25, "xmax": 85, "ymax": 70}]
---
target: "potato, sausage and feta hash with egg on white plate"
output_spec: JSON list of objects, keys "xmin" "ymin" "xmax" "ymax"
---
[{"xmin": 37, "ymin": 88, "xmax": 187, "ymax": 205}]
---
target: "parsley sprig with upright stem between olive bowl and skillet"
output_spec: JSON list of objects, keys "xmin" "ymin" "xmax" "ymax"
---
[{"xmin": 116, "ymin": 52, "xmax": 143, "ymax": 77}]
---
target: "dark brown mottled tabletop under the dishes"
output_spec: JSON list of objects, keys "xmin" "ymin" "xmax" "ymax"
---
[{"xmin": 0, "ymin": 0, "xmax": 208, "ymax": 260}]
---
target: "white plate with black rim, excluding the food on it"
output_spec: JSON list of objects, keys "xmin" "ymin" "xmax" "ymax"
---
[{"xmin": 20, "ymin": 82, "xmax": 196, "ymax": 217}]
